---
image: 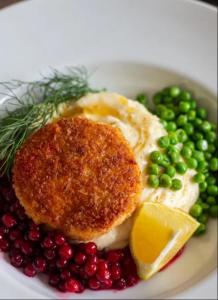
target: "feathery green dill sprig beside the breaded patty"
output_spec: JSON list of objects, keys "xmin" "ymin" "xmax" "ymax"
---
[{"xmin": 0, "ymin": 68, "xmax": 93, "ymax": 176}]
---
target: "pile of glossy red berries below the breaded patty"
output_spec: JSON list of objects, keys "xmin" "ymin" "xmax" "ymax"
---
[{"xmin": 0, "ymin": 178, "xmax": 139, "ymax": 293}]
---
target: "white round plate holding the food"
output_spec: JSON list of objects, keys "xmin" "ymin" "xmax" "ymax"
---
[{"xmin": 0, "ymin": 0, "xmax": 217, "ymax": 299}]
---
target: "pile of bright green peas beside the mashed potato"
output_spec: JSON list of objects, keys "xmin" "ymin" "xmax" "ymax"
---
[{"xmin": 136, "ymin": 86, "xmax": 218, "ymax": 235}]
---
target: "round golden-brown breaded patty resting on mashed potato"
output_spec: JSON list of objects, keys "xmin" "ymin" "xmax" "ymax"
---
[{"xmin": 13, "ymin": 117, "xmax": 141, "ymax": 240}]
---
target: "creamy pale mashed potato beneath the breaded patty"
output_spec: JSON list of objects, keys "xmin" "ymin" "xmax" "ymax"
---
[{"xmin": 60, "ymin": 92, "xmax": 199, "ymax": 248}]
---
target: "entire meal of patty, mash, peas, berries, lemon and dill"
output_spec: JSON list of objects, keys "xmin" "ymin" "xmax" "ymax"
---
[{"xmin": 0, "ymin": 68, "xmax": 218, "ymax": 293}]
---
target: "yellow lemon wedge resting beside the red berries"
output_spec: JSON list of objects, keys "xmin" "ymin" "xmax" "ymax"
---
[{"xmin": 130, "ymin": 202, "xmax": 199, "ymax": 280}]
